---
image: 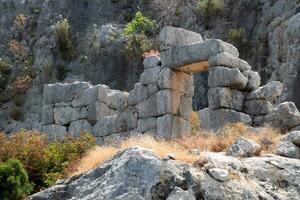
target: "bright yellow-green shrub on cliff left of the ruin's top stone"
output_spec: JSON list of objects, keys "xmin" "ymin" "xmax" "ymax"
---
[{"xmin": 123, "ymin": 11, "xmax": 159, "ymax": 37}]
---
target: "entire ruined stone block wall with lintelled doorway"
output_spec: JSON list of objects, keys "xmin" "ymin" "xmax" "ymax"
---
[{"xmin": 41, "ymin": 27, "xmax": 300, "ymax": 143}]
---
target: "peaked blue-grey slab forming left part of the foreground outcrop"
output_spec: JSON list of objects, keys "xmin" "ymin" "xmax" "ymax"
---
[{"xmin": 29, "ymin": 147, "xmax": 162, "ymax": 200}]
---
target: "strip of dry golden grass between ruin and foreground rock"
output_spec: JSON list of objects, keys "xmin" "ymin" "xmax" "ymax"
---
[{"xmin": 71, "ymin": 123, "xmax": 280, "ymax": 175}]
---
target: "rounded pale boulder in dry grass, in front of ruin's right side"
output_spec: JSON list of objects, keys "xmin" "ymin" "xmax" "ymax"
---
[{"xmin": 227, "ymin": 138, "xmax": 261, "ymax": 157}]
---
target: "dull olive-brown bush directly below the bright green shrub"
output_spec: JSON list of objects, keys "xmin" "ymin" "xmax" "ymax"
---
[{"xmin": 124, "ymin": 34, "xmax": 158, "ymax": 59}]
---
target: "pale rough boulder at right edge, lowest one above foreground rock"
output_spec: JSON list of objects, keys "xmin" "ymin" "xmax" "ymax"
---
[{"xmin": 276, "ymin": 141, "xmax": 300, "ymax": 159}]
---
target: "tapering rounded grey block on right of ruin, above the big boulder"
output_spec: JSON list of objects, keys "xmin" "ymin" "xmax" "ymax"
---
[{"xmin": 247, "ymin": 81, "xmax": 282, "ymax": 102}]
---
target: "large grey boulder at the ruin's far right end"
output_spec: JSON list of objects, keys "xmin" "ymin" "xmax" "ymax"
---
[{"xmin": 256, "ymin": 102, "xmax": 300, "ymax": 130}]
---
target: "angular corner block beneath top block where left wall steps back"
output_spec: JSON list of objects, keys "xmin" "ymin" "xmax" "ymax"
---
[{"xmin": 87, "ymin": 102, "xmax": 113, "ymax": 124}]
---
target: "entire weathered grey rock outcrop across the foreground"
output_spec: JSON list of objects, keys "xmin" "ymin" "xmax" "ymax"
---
[{"xmin": 29, "ymin": 147, "xmax": 300, "ymax": 200}]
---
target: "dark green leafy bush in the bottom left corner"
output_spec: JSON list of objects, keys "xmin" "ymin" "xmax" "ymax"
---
[{"xmin": 0, "ymin": 159, "xmax": 32, "ymax": 200}]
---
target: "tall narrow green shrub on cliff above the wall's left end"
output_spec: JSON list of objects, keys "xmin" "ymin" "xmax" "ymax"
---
[{"xmin": 55, "ymin": 19, "xmax": 75, "ymax": 60}]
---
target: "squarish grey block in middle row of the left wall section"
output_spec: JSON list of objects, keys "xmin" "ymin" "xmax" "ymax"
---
[{"xmin": 54, "ymin": 107, "xmax": 81, "ymax": 125}]
